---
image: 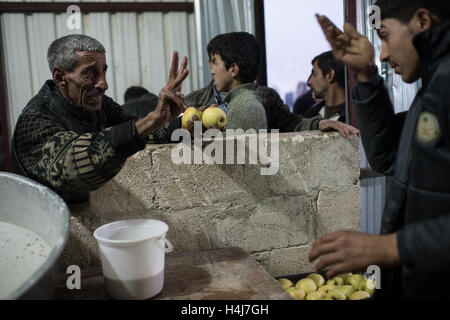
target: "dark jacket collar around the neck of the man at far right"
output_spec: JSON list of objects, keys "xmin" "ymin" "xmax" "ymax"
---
[{"xmin": 413, "ymin": 20, "xmax": 450, "ymax": 85}]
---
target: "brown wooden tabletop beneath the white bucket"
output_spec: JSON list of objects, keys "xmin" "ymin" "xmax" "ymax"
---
[{"xmin": 55, "ymin": 248, "xmax": 292, "ymax": 300}]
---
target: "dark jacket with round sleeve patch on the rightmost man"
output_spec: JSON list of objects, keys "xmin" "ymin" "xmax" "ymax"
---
[{"xmin": 353, "ymin": 21, "xmax": 450, "ymax": 299}]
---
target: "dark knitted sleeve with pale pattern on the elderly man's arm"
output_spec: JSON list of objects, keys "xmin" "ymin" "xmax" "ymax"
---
[{"xmin": 14, "ymin": 113, "xmax": 145, "ymax": 198}]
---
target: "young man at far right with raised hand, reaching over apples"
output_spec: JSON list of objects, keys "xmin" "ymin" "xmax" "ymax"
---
[{"xmin": 310, "ymin": 0, "xmax": 450, "ymax": 299}]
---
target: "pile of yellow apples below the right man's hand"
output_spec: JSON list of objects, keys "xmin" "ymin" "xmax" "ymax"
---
[{"xmin": 278, "ymin": 272, "xmax": 375, "ymax": 300}]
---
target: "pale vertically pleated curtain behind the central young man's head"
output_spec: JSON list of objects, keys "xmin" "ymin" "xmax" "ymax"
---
[{"xmin": 194, "ymin": 0, "xmax": 255, "ymax": 87}]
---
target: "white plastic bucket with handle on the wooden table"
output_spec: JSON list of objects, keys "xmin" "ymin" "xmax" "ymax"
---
[{"xmin": 94, "ymin": 220, "xmax": 173, "ymax": 300}]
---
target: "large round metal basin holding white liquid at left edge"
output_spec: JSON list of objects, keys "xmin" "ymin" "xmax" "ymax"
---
[{"xmin": 0, "ymin": 172, "xmax": 70, "ymax": 299}]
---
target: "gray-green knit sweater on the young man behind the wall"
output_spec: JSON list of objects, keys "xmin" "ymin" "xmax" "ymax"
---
[{"xmin": 223, "ymin": 83, "xmax": 267, "ymax": 131}]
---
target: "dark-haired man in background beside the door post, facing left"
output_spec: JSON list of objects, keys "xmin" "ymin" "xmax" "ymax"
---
[{"xmin": 303, "ymin": 51, "xmax": 345, "ymax": 122}]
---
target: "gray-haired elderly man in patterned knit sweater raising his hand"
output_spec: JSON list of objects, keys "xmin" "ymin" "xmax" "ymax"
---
[{"xmin": 11, "ymin": 35, "xmax": 189, "ymax": 203}]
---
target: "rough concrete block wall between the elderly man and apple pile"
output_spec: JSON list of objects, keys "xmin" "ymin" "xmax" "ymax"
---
[{"xmin": 60, "ymin": 131, "xmax": 360, "ymax": 276}]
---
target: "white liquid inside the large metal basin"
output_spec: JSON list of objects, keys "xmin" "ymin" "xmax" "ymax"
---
[{"xmin": 0, "ymin": 221, "xmax": 50, "ymax": 299}]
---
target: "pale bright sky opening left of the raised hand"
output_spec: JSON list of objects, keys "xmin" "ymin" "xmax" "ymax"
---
[{"xmin": 264, "ymin": 0, "xmax": 344, "ymax": 110}]
